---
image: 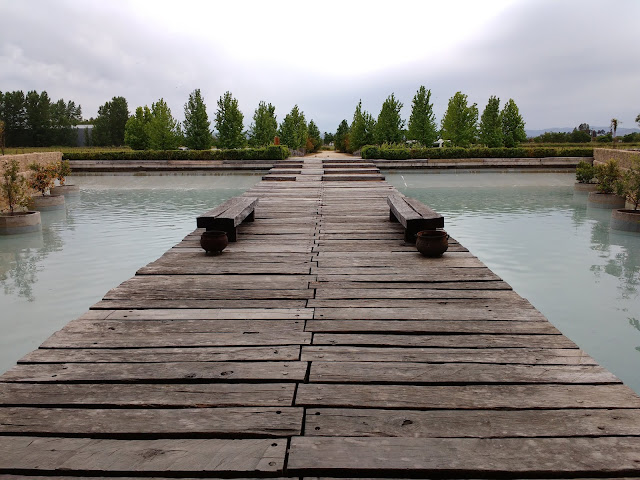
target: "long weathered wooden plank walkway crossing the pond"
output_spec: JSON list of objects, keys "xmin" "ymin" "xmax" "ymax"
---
[{"xmin": 0, "ymin": 159, "xmax": 640, "ymax": 480}]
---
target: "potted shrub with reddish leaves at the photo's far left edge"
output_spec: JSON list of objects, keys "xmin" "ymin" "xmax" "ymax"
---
[{"xmin": 0, "ymin": 158, "xmax": 41, "ymax": 235}]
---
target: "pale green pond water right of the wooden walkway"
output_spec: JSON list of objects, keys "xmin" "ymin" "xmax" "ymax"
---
[{"xmin": 387, "ymin": 172, "xmax": 640, "ymax": 392}]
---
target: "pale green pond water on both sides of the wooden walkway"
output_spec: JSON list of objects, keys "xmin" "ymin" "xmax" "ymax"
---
[{"xmin": 0, "ymin": 171, "xmax": 640, "ymax": 392}]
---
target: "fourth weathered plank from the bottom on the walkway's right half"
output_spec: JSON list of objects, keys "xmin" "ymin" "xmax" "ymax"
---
[{"xmin": 310, "ymin": 362, "xmax": 620, "ymax": 384}]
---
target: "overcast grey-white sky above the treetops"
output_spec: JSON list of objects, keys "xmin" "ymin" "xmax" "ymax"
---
[{"xmin": 0, "ymin": 0, "xmax": 640, "ymax": 131}]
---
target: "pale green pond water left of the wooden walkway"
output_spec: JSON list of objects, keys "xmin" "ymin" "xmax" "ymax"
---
[{"xmin": 0, "ymin": 173, "xmax": 260, "ymax": 371}]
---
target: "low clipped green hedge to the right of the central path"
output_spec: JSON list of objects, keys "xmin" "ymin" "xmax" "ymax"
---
[{"xmin": 360, "ymin": 145, "xmax": 593, "ymax": 160}]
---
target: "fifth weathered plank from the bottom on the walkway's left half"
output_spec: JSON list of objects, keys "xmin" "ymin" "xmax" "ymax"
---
[{"xmin": 18, "ymin": 345, "xmax": 300, "ymax": 363}]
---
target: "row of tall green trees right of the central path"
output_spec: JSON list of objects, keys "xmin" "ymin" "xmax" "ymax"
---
[{"xmin": 336, "ymin": 86, "xmax": 526, "ymax": 151}]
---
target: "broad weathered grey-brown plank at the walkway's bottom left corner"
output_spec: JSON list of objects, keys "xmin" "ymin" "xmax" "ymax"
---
[{"xmin": 0, "ymin": 436, "xmax": 287, "ymax": 475}]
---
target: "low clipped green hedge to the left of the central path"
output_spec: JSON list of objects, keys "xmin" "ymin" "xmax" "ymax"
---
[{"xmin": 62, "ymin": 145, "xmax": 289, "ymax": 161}]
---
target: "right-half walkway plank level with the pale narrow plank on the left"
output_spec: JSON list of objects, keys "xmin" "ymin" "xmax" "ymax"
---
[{"xmin": 314, "ymin": 306, "xmax": 546, "ymax": 321}]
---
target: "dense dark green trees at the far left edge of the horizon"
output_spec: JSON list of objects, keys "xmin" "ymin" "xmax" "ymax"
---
[{"xmin": 0, "ymin": 90, "xmax": 82, "ymax": 147}]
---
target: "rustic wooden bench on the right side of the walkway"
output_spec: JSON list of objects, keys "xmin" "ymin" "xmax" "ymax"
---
[{"xmin": 387, "ymin": 194, "xmax": 444, "ymax": 243}]
